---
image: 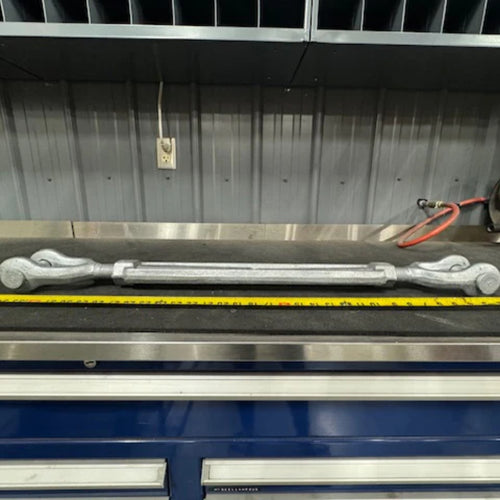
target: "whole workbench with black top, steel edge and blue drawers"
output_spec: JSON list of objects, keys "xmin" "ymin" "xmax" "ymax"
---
[{"xmin": 0, "ymin": 239, "xmax": 500, "ymax": 500}]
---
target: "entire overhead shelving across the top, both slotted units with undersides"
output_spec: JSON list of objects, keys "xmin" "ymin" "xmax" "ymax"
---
[{"xmin": 0, "ymin": 0, "xmax": 500, "ymax": 90}]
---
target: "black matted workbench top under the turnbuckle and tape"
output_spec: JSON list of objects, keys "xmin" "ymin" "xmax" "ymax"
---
[{"xmin": 0, "ymin": 239, "xmax": 500, "ymax": 337}]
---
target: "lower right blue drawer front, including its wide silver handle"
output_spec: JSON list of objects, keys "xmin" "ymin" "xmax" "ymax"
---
[{"xmin": 201, "ymin": 456, "xmax": 500, "ymax": 500}]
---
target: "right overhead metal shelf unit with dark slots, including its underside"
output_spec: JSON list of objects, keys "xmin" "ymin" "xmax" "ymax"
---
[{"xmin": 294, "ymin": 0, "xmax": 500, "ymax": 91}]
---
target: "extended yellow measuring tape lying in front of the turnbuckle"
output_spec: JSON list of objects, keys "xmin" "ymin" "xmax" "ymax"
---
[{"xmin": 0, "ymin": 294, "xmax": 500, "ymax": 308}]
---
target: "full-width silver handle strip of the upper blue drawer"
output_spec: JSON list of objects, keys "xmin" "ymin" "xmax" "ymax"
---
[{"xmin": 0, "ymin": 372, "xmax": 500, "ymax": 400}]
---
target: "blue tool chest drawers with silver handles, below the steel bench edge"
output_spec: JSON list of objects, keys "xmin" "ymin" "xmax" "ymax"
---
[{"xmin": 0, "ymin": 365, "xmax": 500, "ymax": 500}]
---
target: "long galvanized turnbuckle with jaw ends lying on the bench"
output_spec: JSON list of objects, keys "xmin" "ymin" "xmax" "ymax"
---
[{"xmin": 0, "ymin": 249, "xmax": 500, "ymax": 295}]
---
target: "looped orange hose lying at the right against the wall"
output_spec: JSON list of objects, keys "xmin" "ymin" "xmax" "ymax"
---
[{"xmin": 397, "ymin": 197, "xmax": 488, "ymax": 248}]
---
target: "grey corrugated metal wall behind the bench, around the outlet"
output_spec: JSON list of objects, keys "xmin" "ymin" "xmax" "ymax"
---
[{"xmin": 0, "ymin": 82, "xmax": 500, "ymax": 223}]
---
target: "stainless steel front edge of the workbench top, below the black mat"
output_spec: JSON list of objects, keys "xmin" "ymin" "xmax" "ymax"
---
[{"xmin": 0, "ymin": 331, "xmax": 500, "ymax": 362}]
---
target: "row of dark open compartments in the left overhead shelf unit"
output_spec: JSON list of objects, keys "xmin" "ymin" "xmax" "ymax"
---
[{"xmin": 0, "ymin": 0, "xmax": 311, "ymax": 29}]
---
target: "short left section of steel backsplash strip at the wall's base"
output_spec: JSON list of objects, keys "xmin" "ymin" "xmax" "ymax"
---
[{"xmin": 0, "ymin": 220, "xmax": 73, "ymax": 238}]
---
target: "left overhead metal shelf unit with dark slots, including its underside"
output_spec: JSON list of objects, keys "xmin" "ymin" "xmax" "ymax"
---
[{"xmin": 0, "ymin": 0, "xmax": 311, "ymax": 86}]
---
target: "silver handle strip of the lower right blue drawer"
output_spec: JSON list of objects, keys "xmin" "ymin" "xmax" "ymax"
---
[{"xmin": 202, "ymin": 455, "xmax": 500, "ymax": 487}]
